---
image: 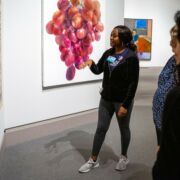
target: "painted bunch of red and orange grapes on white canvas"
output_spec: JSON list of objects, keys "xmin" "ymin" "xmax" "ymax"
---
[{"xmin": 46, "ymin": 0, "xmax": 104, "ymax": 80}]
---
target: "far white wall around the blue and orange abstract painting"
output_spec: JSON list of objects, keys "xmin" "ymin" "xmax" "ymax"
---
[{"xmin": 124, "ymin": 0, "xmax": 180, "ymax": 67}]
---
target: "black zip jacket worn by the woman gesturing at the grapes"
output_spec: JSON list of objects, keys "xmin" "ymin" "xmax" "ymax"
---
[{"xmin": 91, "ymin": 48, "xmax": 139, "ymax": 108}]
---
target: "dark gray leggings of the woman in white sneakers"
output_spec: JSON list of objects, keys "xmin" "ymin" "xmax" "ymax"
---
[{"xmin": 92, "ymin": 98, "xmax": 133, "ymax": 156}]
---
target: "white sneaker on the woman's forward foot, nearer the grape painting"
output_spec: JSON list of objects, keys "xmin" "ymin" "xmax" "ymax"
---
[{"xmin": 79, "ymin": 158, "xmax": 99, "ymax": 173}]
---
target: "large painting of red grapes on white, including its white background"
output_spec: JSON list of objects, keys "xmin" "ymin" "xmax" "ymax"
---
[{"xmin": 42, "ymin": 0, "xmax": 105, "ymax": 86}]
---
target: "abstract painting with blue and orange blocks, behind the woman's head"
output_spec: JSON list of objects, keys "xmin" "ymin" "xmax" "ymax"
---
[{"xmin": 124, "ymin": 18, "xmax": 152, "ymax": 61}]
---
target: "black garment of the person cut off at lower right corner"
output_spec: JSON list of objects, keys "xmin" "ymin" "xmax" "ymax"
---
[{"xmin": 153, "ymin": 86, "xmax": 180, "ymax": 180}]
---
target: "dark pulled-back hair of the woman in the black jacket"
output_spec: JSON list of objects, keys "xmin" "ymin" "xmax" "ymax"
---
[{"xmin": 114, "ymin": 25, "xmax": 137, "ymax": 51}]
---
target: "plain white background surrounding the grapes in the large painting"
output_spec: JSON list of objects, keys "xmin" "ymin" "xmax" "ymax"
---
[{"xmin": 41, "ymin": 0, "xmax": 105, "ymax": 89}]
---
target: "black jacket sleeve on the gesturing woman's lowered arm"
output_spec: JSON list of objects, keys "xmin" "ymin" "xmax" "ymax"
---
[{"xmin": 122, "ymin": 56, "xmax": 139, "ymax": 109}]
